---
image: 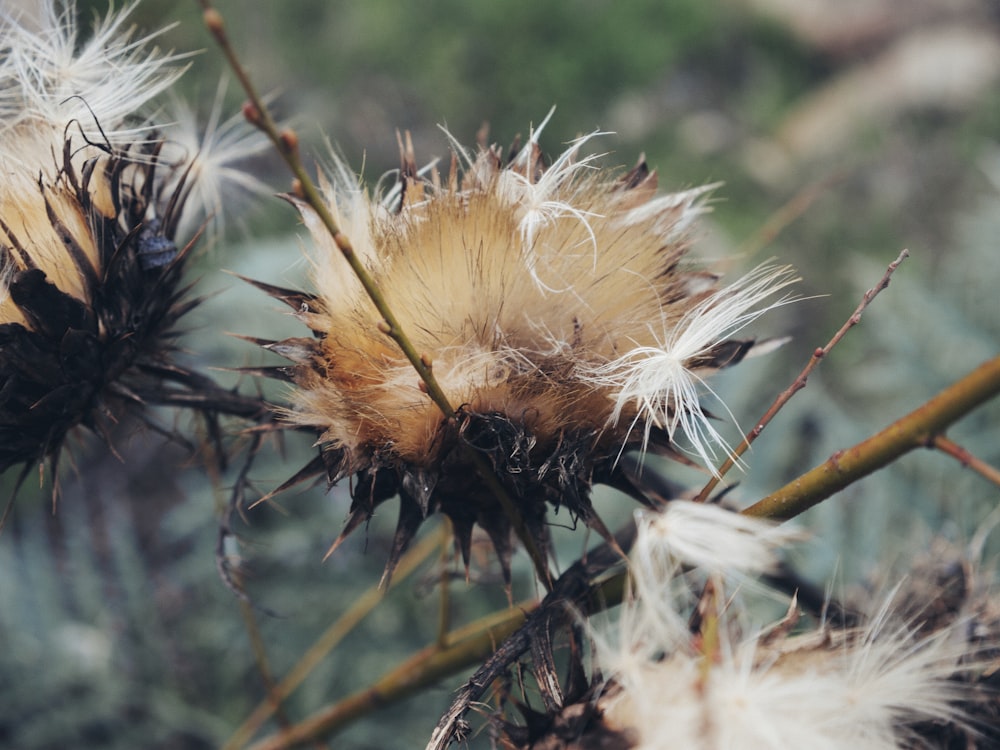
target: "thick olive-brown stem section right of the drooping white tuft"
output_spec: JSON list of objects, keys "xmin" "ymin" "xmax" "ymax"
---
[{"xmin": 743, "ymin": 357, "xmax": 1000, "ymax": 520}]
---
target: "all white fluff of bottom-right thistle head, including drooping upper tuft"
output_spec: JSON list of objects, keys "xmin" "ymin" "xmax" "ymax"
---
[{"xmin": 591, "ymin": 501, "xmax": 976, "ymax": 750}]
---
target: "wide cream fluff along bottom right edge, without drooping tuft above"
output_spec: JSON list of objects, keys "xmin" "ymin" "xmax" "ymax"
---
[{"xmin": 595, "ymin": 589, "xmax": 971, "ymax": 750}]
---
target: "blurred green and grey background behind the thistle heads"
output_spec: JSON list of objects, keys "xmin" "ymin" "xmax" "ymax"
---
[{"xmin": 0, "ymin": 0, "xmax": 1000, "ymax": 750}]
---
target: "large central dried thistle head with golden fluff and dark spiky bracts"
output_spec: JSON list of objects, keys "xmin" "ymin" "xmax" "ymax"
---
[{"xmin": 250, "ymin": 120, "xmax": 794, "ymax": 584}]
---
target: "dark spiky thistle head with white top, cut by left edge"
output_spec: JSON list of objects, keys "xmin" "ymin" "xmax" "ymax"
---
[{"xmin": 0, "ymin": 0, "xmax": 262, "ymax": 488}]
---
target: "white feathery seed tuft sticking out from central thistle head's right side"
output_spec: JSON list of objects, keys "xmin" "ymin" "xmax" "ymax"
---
[{"xmin": 578, "ymin": 265, "xmax": 799, "ymax": 472}]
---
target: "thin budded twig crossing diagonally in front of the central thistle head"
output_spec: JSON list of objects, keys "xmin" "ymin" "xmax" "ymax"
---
[{"xmin": 198, "ymin": 0, "xmax": 552, "ymax": 590}]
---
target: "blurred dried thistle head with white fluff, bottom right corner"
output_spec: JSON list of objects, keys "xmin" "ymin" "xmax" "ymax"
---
[{"xmin": 501, "ymin": 501, "xmax": 1000, "ymax": 750}]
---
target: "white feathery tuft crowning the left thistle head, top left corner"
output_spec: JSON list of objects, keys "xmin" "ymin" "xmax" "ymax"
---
[{"xmin": 0, "ymin": 0, "xmax": 183, "ymax": 156}]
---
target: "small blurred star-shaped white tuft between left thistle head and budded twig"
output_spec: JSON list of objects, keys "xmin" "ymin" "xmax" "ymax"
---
[{"xmin": 161, "ymin": 78, "xmax": 271, "ymax": 237}]
